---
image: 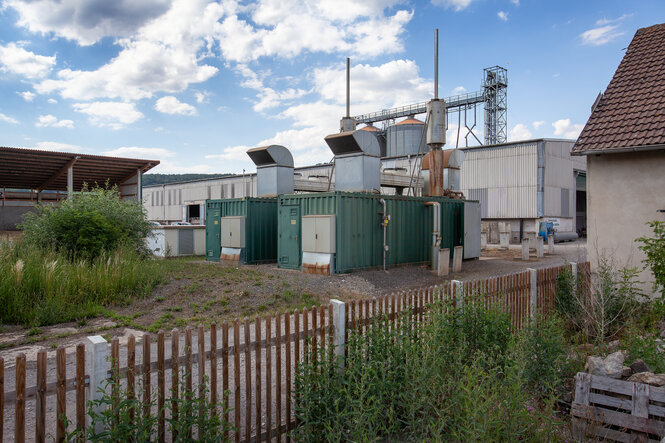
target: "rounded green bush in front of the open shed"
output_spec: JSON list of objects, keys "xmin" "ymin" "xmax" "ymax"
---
[{"xmin": 20, "ymin": 186, "xmax": 152, "ymax": 259}]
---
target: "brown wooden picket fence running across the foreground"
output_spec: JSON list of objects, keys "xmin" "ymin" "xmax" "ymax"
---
[{"xmin": 0, "ymin": 263, "xmax": 588, "ymax": 443}]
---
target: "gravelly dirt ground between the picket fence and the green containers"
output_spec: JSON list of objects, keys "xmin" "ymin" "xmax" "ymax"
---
[{"xmin": 0, "ymin": 242, "xmax": 585, "ymax": 354}]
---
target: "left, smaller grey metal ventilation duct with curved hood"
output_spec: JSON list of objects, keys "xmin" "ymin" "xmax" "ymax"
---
[{"xmin": 247, "ymin": 145, "xmax": 293, "ymax": 197}]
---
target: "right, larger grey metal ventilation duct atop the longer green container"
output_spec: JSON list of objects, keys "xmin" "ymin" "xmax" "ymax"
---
[{"xmin": 325, "ymin": 130, "xmax": 381, "ymax": 191}]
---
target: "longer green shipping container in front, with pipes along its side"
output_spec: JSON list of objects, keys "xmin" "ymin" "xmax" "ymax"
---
[{"xmin": 277, "ymin": 191, "xmax": 464, "ymax": 273}]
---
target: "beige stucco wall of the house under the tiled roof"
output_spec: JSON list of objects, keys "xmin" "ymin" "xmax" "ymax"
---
[{"xmin": 587, "ymin": 151, "xmax": 665, "ymax": 293}]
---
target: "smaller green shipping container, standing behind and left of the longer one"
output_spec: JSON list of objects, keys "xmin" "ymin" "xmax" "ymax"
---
[{"xmin": 206, "ymin": 197, "xmax": 277, "ymax": 264}]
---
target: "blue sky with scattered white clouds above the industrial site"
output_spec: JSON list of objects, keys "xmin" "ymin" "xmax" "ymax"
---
[{"xmin": 0, "ymin": 0, "xmax": 665, "ymax": 173}]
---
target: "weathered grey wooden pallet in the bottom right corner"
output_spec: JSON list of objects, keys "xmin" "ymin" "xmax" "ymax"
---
[{"xmin": 570, "ymin": 372, "xmax": 665, "ymax": 443}]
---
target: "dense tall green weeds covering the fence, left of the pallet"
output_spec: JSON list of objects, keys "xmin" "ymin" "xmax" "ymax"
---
[{"xmin": 295, "ymin": 303, "xmax": 569, "ymax": 441}]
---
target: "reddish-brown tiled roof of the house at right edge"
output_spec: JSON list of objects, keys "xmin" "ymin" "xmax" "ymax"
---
[{"xmin": 572, "ymin": 24, "xmax": 665, "ymax": 154}]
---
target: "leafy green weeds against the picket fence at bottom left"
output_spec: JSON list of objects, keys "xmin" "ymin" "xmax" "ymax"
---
[{"xmin": 61, "ymin": 372, "xmax": 233, "ymax": 443}]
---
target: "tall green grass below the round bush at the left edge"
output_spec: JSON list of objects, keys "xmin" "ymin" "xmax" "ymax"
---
[{"xmin": 0, "ymin": 241, "xmax": 165, "ymax": 326}]
